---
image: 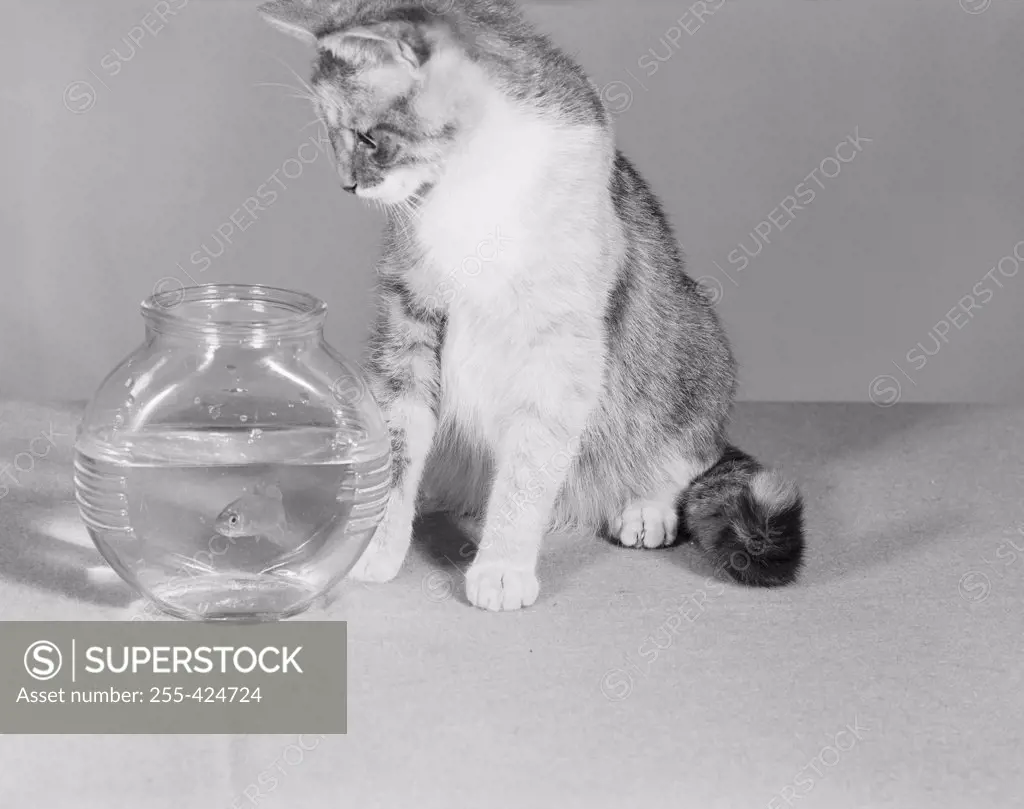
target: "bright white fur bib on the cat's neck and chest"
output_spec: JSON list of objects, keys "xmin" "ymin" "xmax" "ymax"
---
[{"xmin": 406, "ymin": 82, "xmax": 611, "ymax": 445}]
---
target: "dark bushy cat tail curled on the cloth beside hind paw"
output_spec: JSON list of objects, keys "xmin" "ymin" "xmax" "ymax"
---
[{"xmin": 676, "ymin": 445, "xmax": 804, "ymax": 587}]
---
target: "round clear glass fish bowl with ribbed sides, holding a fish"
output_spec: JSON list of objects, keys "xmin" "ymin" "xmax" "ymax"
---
[{"xmin": 75, "ymin": 284, "xmax": 391, "ymax": 621}]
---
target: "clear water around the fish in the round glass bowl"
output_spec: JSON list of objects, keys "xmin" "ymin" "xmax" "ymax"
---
[{"xmin": 75, "ymin": 425, "xmax": 390, "ymax": 621}]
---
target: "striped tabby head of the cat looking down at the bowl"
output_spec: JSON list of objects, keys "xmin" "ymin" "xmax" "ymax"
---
[{"xmin": 259, "ymin": 0, "xmax": 459, "ymax": 205}]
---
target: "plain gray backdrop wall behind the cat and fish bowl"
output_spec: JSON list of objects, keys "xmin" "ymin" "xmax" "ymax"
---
[{"xmin": 0, "ymin": 0, "xmax": 1024, "ymax": 401}]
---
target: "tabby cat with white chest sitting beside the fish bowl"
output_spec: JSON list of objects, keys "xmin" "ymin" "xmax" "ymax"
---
[{"xmin": 260, "ymin": 0, "xmax": 804, "ymax": 610}]
